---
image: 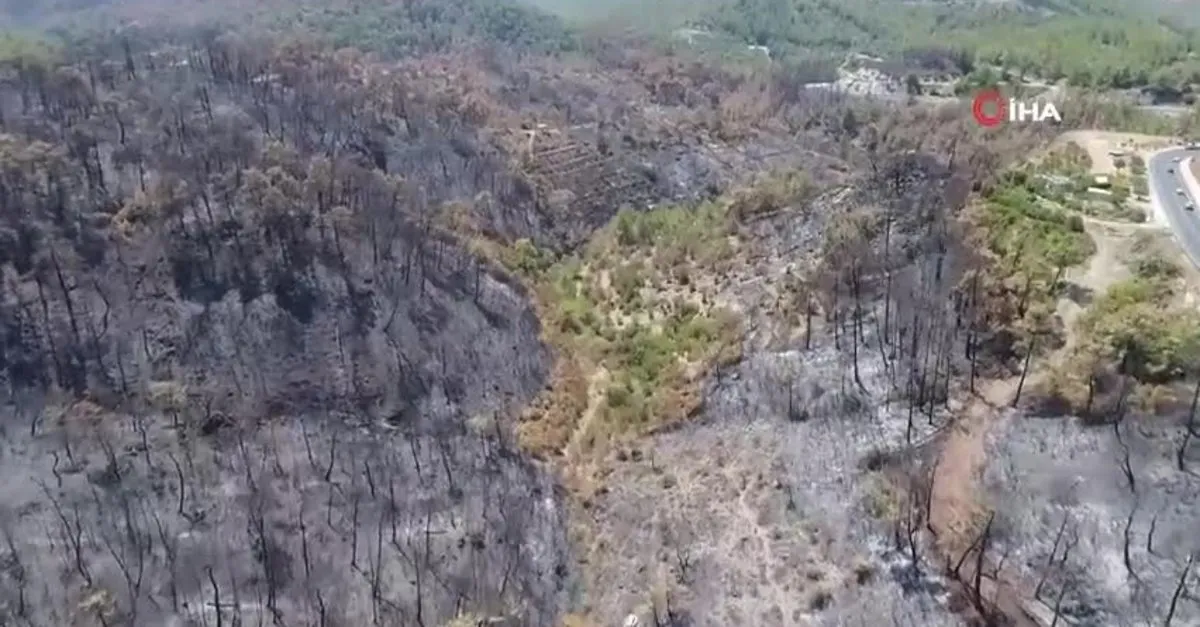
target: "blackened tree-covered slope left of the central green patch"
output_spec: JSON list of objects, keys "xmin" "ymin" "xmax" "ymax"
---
[{"xmin": 0, "ymin": 25, "xmax": 916, "ymax": 625}]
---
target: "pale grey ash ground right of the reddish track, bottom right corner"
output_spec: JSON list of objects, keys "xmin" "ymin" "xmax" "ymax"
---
[{"xmin": 984, "ymin": 412, "xmax": 1200, "ymax": 626}]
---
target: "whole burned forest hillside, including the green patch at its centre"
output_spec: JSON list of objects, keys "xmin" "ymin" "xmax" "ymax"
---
[{"xmin": 0, "ymin": 2, "xmax": 1200, "ymax": 627}]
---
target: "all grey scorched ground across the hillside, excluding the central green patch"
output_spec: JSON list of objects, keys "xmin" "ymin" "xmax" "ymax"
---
[{"xmin": 0, "ymin": 18, "xmax": 1196, "ymax": 626}]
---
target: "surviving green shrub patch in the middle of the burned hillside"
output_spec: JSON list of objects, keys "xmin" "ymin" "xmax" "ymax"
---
[{"xmin": 513, "ymin": 202, "xmax": 740, "ymax": 450}]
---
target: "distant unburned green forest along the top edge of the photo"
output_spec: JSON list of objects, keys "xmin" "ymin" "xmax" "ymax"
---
[{"xmin": 11, "ymin": 0, "xmax": 1200, "ymax": 90}]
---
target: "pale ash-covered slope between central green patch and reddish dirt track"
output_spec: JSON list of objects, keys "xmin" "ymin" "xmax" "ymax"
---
[{"xmin": 568, "ymin": 158, "xmax": 964, "ymax": 626}]
